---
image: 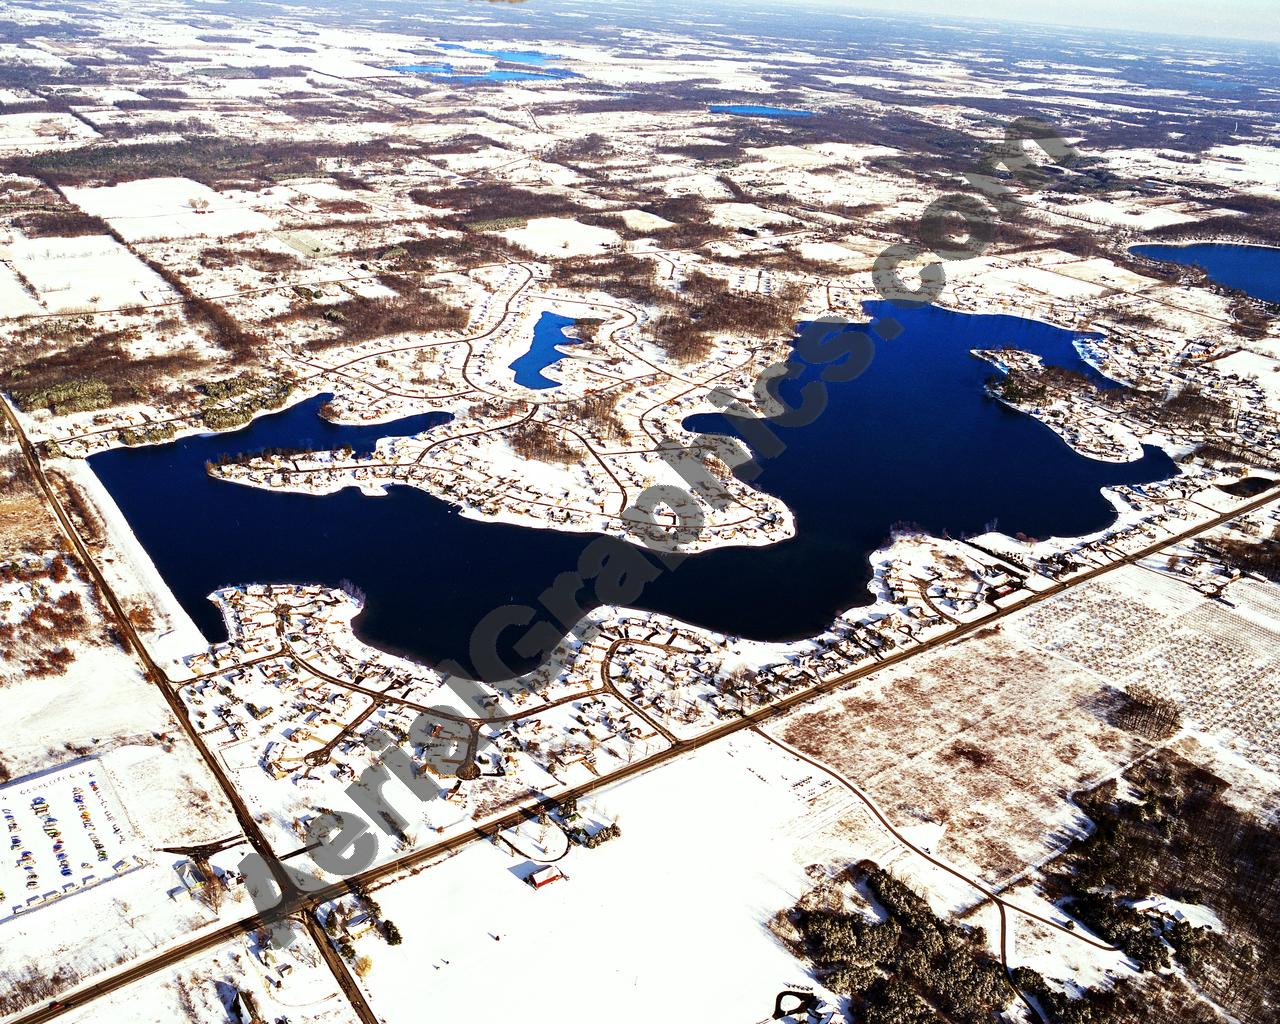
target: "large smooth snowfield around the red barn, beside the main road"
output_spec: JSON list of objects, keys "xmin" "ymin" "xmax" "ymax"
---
[{"xmin": 357, "ymin": 736, "xmax": 839, "ymax": 1024}]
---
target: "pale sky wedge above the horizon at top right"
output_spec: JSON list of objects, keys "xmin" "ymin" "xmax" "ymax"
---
[{"xmin": 829, "ymin": 0, "xmax": 1280, "ymax": 42}]
